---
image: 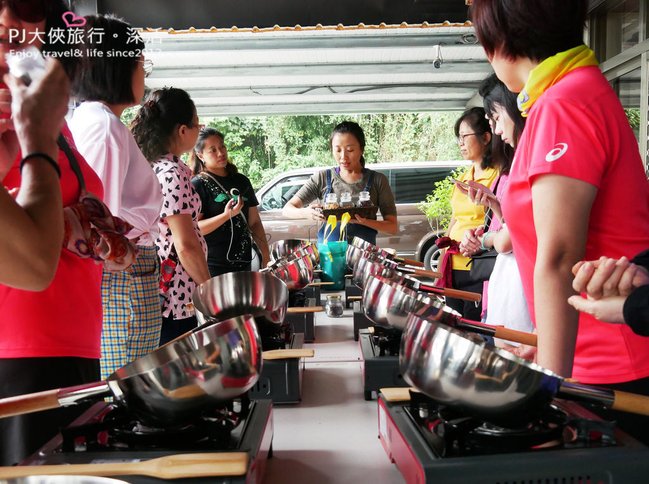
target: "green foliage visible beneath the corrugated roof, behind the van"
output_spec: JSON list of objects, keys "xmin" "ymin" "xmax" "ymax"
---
[{"xmin": 206, "ymin": 113, "xmax": 460, "ymax": 188}]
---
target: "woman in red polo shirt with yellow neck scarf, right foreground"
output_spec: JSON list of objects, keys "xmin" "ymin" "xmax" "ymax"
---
[{"xmin": 472, "ymin": 0, "xmax": 649, "ymax": 440}]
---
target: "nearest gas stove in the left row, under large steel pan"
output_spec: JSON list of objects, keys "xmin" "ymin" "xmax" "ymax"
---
[{"xmin": 21, "ymin": 396, "xmax": 273, "ymax": 484}]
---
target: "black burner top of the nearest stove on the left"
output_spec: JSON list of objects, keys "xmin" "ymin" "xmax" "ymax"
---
[{"xmin": 61, "ymin": 395, "xmax": 250, "ymax": 452}]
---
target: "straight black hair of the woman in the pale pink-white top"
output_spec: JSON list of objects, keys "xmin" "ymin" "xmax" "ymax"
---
[{"xmin": 72, "ymin": 15, "xmax": 144, "ymax": 104}]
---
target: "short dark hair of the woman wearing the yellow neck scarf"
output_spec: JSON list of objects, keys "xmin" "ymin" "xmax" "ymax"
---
[{"xmin": 471, "ymin": 0, "xmax": 588, "ymax": 61}]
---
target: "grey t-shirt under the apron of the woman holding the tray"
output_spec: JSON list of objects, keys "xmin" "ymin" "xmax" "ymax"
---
[{"xmin": 295, "ymin": 168, "xmax": 397, "ymax": 218}]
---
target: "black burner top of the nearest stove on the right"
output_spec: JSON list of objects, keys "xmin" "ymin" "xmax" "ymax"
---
[{"xmin": 406, "ymin": 392, "xmax": 615, "ymax": 457}]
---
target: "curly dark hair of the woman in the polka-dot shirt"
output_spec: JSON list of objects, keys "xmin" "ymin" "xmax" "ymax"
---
[{"xmin": 131, "ymin": 87, "xmax": 196, "ymax": 163}]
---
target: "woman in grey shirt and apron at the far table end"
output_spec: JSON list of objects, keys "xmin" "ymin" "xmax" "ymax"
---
[{"xmin": 283, "ymin": 121, "xmax": 399, "ymax": 244}]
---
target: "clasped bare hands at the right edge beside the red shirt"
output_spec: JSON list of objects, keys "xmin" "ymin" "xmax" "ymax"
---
[{"xmin": 572, "ymin": 257, "xmax": 649, "ymax": 299}]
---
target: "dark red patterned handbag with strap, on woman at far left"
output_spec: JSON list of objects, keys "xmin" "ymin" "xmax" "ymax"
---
[{"xmin": 58, "ymin": 135, "xmax": 137, "ymax": 271}]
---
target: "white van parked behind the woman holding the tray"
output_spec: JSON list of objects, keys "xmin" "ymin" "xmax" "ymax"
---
[{"xmin": 257, "ymin": 161, "xmax": 469, "ymax": 266}]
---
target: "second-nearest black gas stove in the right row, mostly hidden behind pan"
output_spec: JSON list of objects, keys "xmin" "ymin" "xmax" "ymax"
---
[{"xmin": 358, "ymin": 326, "xmax": 408, "ymax": 400}]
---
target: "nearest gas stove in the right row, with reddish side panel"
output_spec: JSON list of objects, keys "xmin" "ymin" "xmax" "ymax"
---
[{"xmin": 378, "ymin": 388, "xmax": 649, "ymax": 484}]
